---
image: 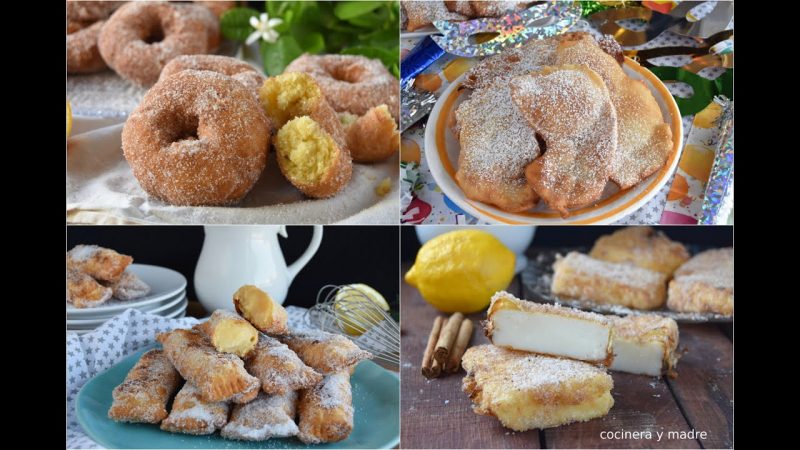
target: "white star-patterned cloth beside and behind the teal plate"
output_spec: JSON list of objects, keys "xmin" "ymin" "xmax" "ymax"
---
[{"xmin": 67, "ymin": 306, "xmax": 309, "ymax": 448}]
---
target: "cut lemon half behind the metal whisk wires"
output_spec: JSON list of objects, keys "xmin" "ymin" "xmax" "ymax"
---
[{"xmin": 334, "ymin": 283, "xmax": 389, "ymax": 336}]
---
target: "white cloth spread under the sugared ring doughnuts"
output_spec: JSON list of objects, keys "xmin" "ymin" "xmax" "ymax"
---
[{"xmin": 67, "ymin": 116, "xmax": 400, "ymax": 224}]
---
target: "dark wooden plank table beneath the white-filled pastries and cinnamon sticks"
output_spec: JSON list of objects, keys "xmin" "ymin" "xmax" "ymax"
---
[{"xmin": 400, "ymin": 265, "xmax": 733, "ymax": 448}]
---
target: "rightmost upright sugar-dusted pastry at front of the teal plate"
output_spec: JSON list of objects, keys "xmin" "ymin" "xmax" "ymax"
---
[{"xmin": 297, "ymin": 370, "xmax": 353, "ymax": 444}]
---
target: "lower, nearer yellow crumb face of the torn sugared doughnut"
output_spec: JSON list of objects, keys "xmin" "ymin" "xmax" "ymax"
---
[{"xmin": 275, "ymin": 116, "xmax": 337, "ymax": 184}]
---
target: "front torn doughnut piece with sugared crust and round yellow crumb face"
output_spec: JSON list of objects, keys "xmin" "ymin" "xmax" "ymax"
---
[{"xmin": 275, "ymin": 116, "xmax": 353, "ymax": 198}]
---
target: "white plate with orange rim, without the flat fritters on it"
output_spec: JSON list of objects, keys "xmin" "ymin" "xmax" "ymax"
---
[{"xmin": 425, "ymin": 57, "xmax": 683, "ymax": 225}]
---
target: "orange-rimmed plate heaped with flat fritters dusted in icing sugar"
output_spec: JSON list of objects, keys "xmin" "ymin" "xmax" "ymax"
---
[{"xmin": 425, "ymin": 32, "xmax": 683, "ymax": 224}]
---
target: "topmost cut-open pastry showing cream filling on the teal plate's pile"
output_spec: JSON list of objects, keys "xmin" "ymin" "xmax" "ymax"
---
[{"xmin": 233, "ymin": 284, "xmax": 289, "ymax": 335}]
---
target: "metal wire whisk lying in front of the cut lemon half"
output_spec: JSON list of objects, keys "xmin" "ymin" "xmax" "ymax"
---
[{"xmin": 306, "ymin": 285, "xmax": 400, "ymax": 370}]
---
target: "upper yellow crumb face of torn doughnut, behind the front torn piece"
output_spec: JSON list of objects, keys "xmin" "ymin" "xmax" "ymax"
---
[{"xmin": 258, "ymin": 72, "xmax": 322, "ymax": 128}]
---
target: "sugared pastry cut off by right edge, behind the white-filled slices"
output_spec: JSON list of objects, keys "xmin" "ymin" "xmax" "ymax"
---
[{"xmin": 667, "ymin": 247, "xmax": 733, "ymax": 316}]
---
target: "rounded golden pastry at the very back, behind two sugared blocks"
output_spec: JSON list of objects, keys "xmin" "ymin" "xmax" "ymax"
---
[{"xmin": 589, "ymin": 227, "xmax": 689, "ymax": 277}]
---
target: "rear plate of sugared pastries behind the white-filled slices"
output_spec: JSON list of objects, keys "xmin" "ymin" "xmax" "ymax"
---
[{"xmin": 522, "ymin": 227, "xmax": 733, "ymax": 322}]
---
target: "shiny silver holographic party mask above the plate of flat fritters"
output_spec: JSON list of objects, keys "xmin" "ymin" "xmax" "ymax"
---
[{"xmin": 432, "ymin": 1, "xmax": 581, "ymax": 57}]
